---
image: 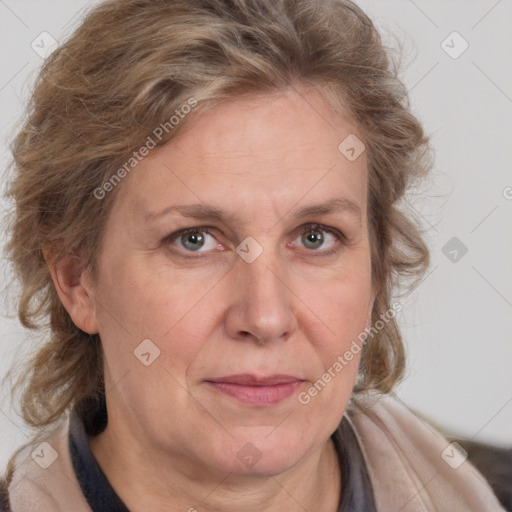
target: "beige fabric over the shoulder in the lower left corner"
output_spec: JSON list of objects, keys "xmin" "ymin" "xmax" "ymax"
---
[{"xmin": 0, "ymin": 420, "xmax": 90, "ymax": 512}]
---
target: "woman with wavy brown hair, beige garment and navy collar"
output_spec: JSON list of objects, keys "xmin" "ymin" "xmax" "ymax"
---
[{"xmin": 0, "ymin": 0, "xmax": 502, "ymax": 512}]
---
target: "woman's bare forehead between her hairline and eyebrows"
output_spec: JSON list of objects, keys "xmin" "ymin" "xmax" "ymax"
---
[{"xmin": 115, "ymin": 90, "xmax": 367, "ymax": 222}]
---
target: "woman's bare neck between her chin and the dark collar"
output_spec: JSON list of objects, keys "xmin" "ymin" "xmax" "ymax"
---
[{"xmin": 89, "ymin": 424, "xmax": 341, "ymax": 512}]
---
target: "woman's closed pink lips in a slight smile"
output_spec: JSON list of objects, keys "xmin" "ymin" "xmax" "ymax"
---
[{"xmin": 206, "ymin": 374, "xmax": 304, "ymax": 406}]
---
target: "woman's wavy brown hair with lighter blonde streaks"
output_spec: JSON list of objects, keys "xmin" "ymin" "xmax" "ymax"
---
[{"xmin": 7, "ymin": 0, "xmax": 430, "ymax": 428}]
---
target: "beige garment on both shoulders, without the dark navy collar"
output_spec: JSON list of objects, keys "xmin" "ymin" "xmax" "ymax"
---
[{"xmin": 5, "ymin": 393, "xmax": 504, "ymax": 512}]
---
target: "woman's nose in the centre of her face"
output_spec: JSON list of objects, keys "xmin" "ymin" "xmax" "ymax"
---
[{"xmin": 226, "ymin": 257, "xmax": 297, "ymax": 344}]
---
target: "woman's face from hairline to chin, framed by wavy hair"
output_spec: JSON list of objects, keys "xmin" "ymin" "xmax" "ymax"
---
[{"xmin": 86, "ymin": 87, "xmax": 373, "ymax": 474}]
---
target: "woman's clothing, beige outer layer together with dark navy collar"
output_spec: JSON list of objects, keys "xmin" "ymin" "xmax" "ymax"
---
[{"xmin": 0, "ymin": 393, "xmax": 504, "ymax": 512}]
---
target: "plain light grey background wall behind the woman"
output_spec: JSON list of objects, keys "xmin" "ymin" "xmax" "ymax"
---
[{"xmin": 0, "ymin": 0, "xmax": 512, "ymax": 467}]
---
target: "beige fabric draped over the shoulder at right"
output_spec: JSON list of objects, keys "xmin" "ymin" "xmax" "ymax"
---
[{"xmin": 347, "ymin": 392, "xmax": 504, "ymax": 512}]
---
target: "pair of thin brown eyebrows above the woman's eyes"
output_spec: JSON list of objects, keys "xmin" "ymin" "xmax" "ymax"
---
[{"xmin": 144, "ymin": 197, "xmax": 362, "ymax": 222}]
